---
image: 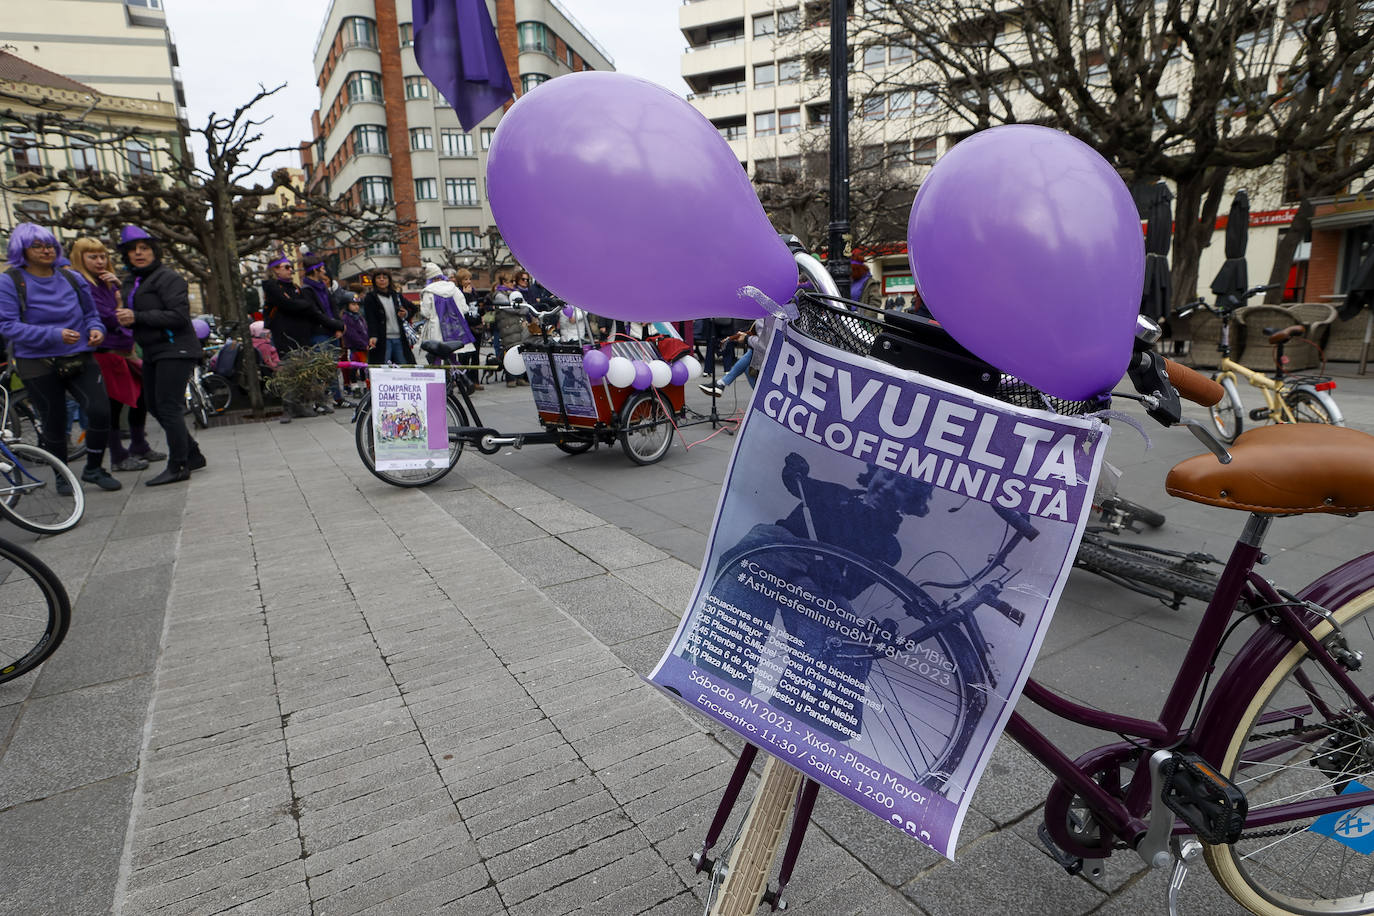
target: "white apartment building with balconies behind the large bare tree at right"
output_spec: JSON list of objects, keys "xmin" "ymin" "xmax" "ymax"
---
[{"xmin": 679, "ymin": 0, "xmax": 1374, "ymax": 301}]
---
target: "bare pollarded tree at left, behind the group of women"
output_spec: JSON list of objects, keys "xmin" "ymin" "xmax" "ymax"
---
[{"xmin": 10, "ymin": 87, "xmax": 414, "ymax": 415}]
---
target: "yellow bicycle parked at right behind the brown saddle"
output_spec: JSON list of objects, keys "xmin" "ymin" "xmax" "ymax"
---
[{"xmin": 1176, "ymin": 286, "xmax": 1345, "ymax": 444}]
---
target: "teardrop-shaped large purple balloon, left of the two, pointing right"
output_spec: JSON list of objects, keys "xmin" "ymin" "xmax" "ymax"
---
[{"xmin": 486, "ymin": 71, "xmax": 797, "ymax": 321}]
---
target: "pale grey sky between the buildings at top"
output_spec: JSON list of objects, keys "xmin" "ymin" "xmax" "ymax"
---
[{"xmin": 166, "ymin": 0, "xmax": 687, "ymax": 177}]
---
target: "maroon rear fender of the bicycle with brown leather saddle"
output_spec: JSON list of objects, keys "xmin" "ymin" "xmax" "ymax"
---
[{"xmin": 1190, "ymin": 552, "xmax": 1374, "ymax": 765}]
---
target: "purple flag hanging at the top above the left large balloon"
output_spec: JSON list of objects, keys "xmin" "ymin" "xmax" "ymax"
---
[{"xmin": 411, "ymin": 0, "xmax": 515, "ymax": 130}]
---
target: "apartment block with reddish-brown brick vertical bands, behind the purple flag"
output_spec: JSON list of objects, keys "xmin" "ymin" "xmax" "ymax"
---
[{"xmin": 311, "ymin": 0, "xmax": 614, "ymax": 284}]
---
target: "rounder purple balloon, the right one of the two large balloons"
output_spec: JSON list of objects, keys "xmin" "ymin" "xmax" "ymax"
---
[{"xmin": 907, "ymin": 125, "xmax": 1145, "ymax": 400}]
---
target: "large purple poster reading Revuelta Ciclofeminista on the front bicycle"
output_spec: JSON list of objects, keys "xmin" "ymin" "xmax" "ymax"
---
[{"xmin": 649, "ymin": 322, "xmax": 1107, "ymax": 858}]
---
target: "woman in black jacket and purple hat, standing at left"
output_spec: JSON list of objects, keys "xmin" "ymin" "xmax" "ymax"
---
[{"xmin": 114, "ymin": 225, "xmax": 205, "ymax": 486}]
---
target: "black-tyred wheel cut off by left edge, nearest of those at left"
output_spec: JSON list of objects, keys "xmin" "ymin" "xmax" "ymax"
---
[{"xmin": 0, "ymin": 540, "xmax": 71, "ymax": 684}]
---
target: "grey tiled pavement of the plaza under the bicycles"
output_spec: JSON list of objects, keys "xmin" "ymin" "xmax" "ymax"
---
[{"xmin": 0, "ymin": 368, "xmax": 1374, "ymax": 916}]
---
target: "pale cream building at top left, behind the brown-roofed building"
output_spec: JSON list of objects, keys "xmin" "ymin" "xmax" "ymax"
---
[{"xmin": 0, "ymin": 0, "xmax": 185, "ymax": 122}]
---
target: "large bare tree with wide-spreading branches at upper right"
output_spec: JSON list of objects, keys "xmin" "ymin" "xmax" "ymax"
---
[{"xmin": 856, "ymin": 0, "xmax": 1374, "ymax": 307}]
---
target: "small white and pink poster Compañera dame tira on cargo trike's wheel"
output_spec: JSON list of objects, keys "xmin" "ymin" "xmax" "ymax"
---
[{"xmin": 368, "ymin": 365, "xmax": 448, "ymax": 471}]
